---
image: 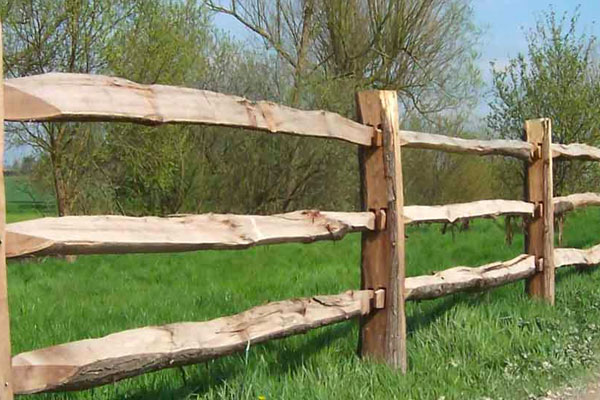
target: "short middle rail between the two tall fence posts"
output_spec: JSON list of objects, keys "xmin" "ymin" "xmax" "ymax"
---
[{"xmin": 404, "ymin": 200, "xmax": 534, "ymax": 224}]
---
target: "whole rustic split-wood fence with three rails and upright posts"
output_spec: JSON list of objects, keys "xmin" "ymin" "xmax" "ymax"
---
[{"xmin": 0, "ymin": 26, "xmax": 600, "ymax": 399}]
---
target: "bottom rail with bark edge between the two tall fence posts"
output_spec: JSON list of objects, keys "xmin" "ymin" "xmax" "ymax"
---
[{"xmin": 406, "ymin": 254, "xmax": 535, "ymax": 300}]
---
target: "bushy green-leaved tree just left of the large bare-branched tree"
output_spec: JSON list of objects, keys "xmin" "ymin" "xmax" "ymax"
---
[{"xmin": 95, "ymin": 0, "xmax": 215, "ymax": 215}]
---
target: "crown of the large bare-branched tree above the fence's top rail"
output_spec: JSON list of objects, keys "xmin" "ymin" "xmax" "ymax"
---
[{"xmin": 208, "ymin": 0, "xmax": 478, "ymax": 114}]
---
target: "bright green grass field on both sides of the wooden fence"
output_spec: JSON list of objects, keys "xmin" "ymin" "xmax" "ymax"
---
[{"xmin": 8, "ymin": 177, "xmax": 600, "ymax": 400}]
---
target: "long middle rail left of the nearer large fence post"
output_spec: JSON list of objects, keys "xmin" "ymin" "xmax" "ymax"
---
[{"xmin": 6, "ymin": 211, "xmax": 375, "ymax": 257}]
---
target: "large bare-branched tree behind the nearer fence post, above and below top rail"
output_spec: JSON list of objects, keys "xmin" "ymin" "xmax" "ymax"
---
[{"xmin": 207, "ymin": 0, "xmax": 478, "ymax": 212}]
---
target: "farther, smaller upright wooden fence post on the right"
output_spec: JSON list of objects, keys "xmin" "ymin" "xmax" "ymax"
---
[{"xmin": 525, "ymin": 118, "xmax": 555, "ymax": 304}]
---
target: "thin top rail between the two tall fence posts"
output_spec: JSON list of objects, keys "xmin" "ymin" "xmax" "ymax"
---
[{"xmin": 400, "ymin": 131, "xmax": 533, "ymax": 160}]
